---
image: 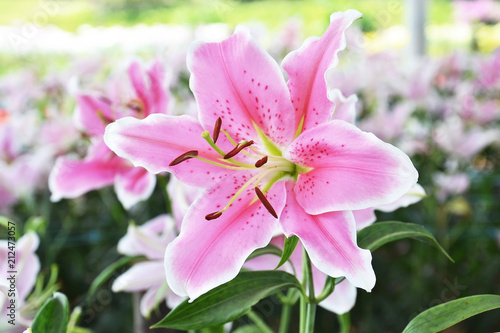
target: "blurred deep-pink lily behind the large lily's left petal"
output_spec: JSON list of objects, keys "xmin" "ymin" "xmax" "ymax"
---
[{"xmin": 49, "ymin": 62, "xmax": 169, "ymax": 209}]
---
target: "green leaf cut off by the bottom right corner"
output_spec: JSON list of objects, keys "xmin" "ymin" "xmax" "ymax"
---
[{"xmin": 403, "ymin": 295, "xmax": 500, "ymax": 333}]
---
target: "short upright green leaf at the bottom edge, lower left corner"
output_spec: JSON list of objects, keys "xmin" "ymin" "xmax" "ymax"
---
[{"xmin": 31, "ymin": 292, "xmax": 69, "ymax": 333}]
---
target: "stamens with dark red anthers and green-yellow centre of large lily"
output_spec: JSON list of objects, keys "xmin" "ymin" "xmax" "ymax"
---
[{"xmin": 170, "ymin": 118, "xmax": 307, "ymax": 220}]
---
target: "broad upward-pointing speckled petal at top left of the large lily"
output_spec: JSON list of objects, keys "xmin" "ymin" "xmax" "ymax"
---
[{"xmin": 188, "ymin": 27, "xmax": 296, "ymax": 146}]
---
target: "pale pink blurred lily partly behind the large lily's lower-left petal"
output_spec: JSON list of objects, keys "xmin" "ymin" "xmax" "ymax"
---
[{"xmin": 112, "ymin": 215, "xmax": 183, "ymax": 318}]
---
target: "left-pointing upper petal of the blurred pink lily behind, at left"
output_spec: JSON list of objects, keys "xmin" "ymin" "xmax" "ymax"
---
[{"xmin": 73, "ymin": 94, "xmax": 116, "ymax": 136}]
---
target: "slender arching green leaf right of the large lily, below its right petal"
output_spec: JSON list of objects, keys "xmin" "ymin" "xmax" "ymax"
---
[{"xmin": 358, "ymin": 221, "xmax": 455, "ymax": 262}]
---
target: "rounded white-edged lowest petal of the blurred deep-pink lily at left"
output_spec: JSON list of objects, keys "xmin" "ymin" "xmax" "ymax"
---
[{"xmin": 115, "ymin": 167, "xmax": 156, "ymax": 209}]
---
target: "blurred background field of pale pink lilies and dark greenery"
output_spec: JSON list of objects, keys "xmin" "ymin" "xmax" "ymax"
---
[{"xmin": 0, "ymin": 0, "xmax": 500, "ymax": 333}]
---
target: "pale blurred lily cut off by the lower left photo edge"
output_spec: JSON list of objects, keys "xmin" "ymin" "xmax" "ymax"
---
[{"xmin": 0, "ymin": 231, "xmax": 40, "ymax": 333}]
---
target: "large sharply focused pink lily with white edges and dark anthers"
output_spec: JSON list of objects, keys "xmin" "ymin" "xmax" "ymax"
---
[{"xmin": 104, "ymin": 10, "xmax": 418, "ymax": 300}]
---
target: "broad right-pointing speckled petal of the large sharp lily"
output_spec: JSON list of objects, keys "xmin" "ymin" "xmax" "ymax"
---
[{"xmin": 284, "ymin": 120, "xmax": 418, "ymax": 214}]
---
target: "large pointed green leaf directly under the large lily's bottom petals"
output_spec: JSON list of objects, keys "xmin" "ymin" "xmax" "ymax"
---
[{"xmin": 153, "ymin": 271, "xmax": 300, "ymax": 330}]
